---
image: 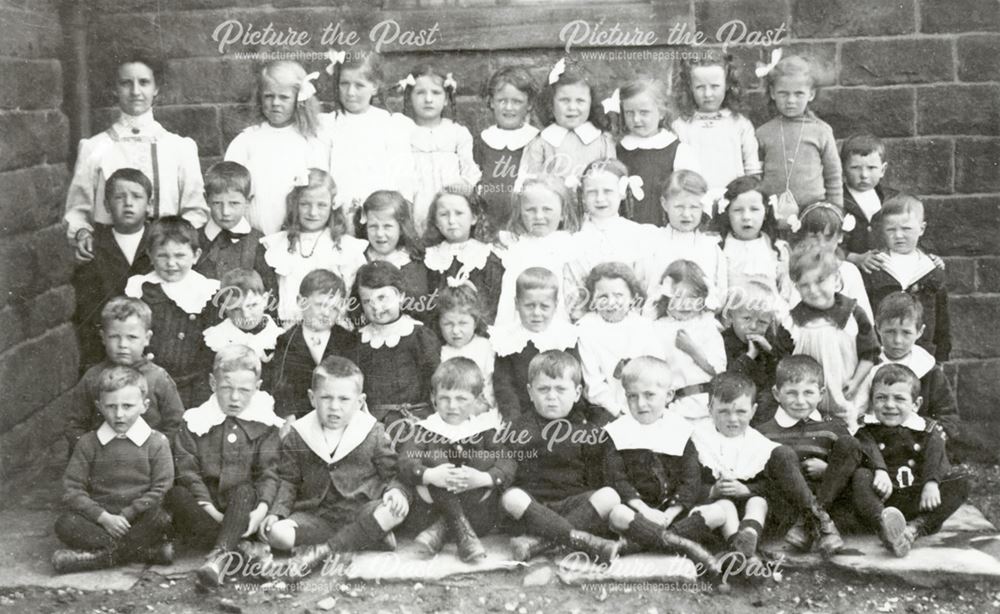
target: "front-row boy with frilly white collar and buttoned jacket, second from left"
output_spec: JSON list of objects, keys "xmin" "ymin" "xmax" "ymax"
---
[{"xmin": 165, "ymin": 345, "xmax": 284, "ymax": 588}]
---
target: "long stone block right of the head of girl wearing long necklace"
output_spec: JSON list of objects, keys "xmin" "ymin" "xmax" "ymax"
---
[{"xmin": 840, "ymin": 39, "xmax": 955, "ymax": 85}]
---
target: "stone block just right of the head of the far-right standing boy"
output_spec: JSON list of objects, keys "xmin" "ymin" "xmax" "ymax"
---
[{"xmin": 884, "ymin": 139, "xmax": 955, "ymax": 194}]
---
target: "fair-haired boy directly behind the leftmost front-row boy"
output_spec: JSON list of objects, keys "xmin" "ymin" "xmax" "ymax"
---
[{"xmin": 65, "ymin": 296, "xmax": 184, "ymax": 451}]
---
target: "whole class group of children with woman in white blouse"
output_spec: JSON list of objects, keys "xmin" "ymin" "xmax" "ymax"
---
[{"xmin": 53, "ymin": 45, "xmax": 969, "ymax": 587}]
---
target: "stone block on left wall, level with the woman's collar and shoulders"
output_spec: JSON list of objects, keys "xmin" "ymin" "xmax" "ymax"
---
[{"xmin": 0, "ymin": 111, "xmax": 69, "ymax": 171}]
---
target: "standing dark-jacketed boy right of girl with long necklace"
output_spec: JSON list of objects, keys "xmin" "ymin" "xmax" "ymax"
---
[{"xmin": 840, "ymin": 134, "xmax": 898, "ymax": 273}]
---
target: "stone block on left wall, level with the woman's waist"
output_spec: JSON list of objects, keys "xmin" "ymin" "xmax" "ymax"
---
[{"xmin": 0, "ymin": 164, "xmax": 69, "ymax": 236}]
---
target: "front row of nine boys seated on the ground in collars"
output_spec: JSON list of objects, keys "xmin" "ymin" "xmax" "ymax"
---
[{"xmin": 53, "ymin": 345, "xmax": 969, "ymax": 587}]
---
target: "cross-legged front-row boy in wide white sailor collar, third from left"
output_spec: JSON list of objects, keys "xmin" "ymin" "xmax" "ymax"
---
[{"xmin": 261, "ymin": 356, "xmax": 411, "ymax": 576}]
